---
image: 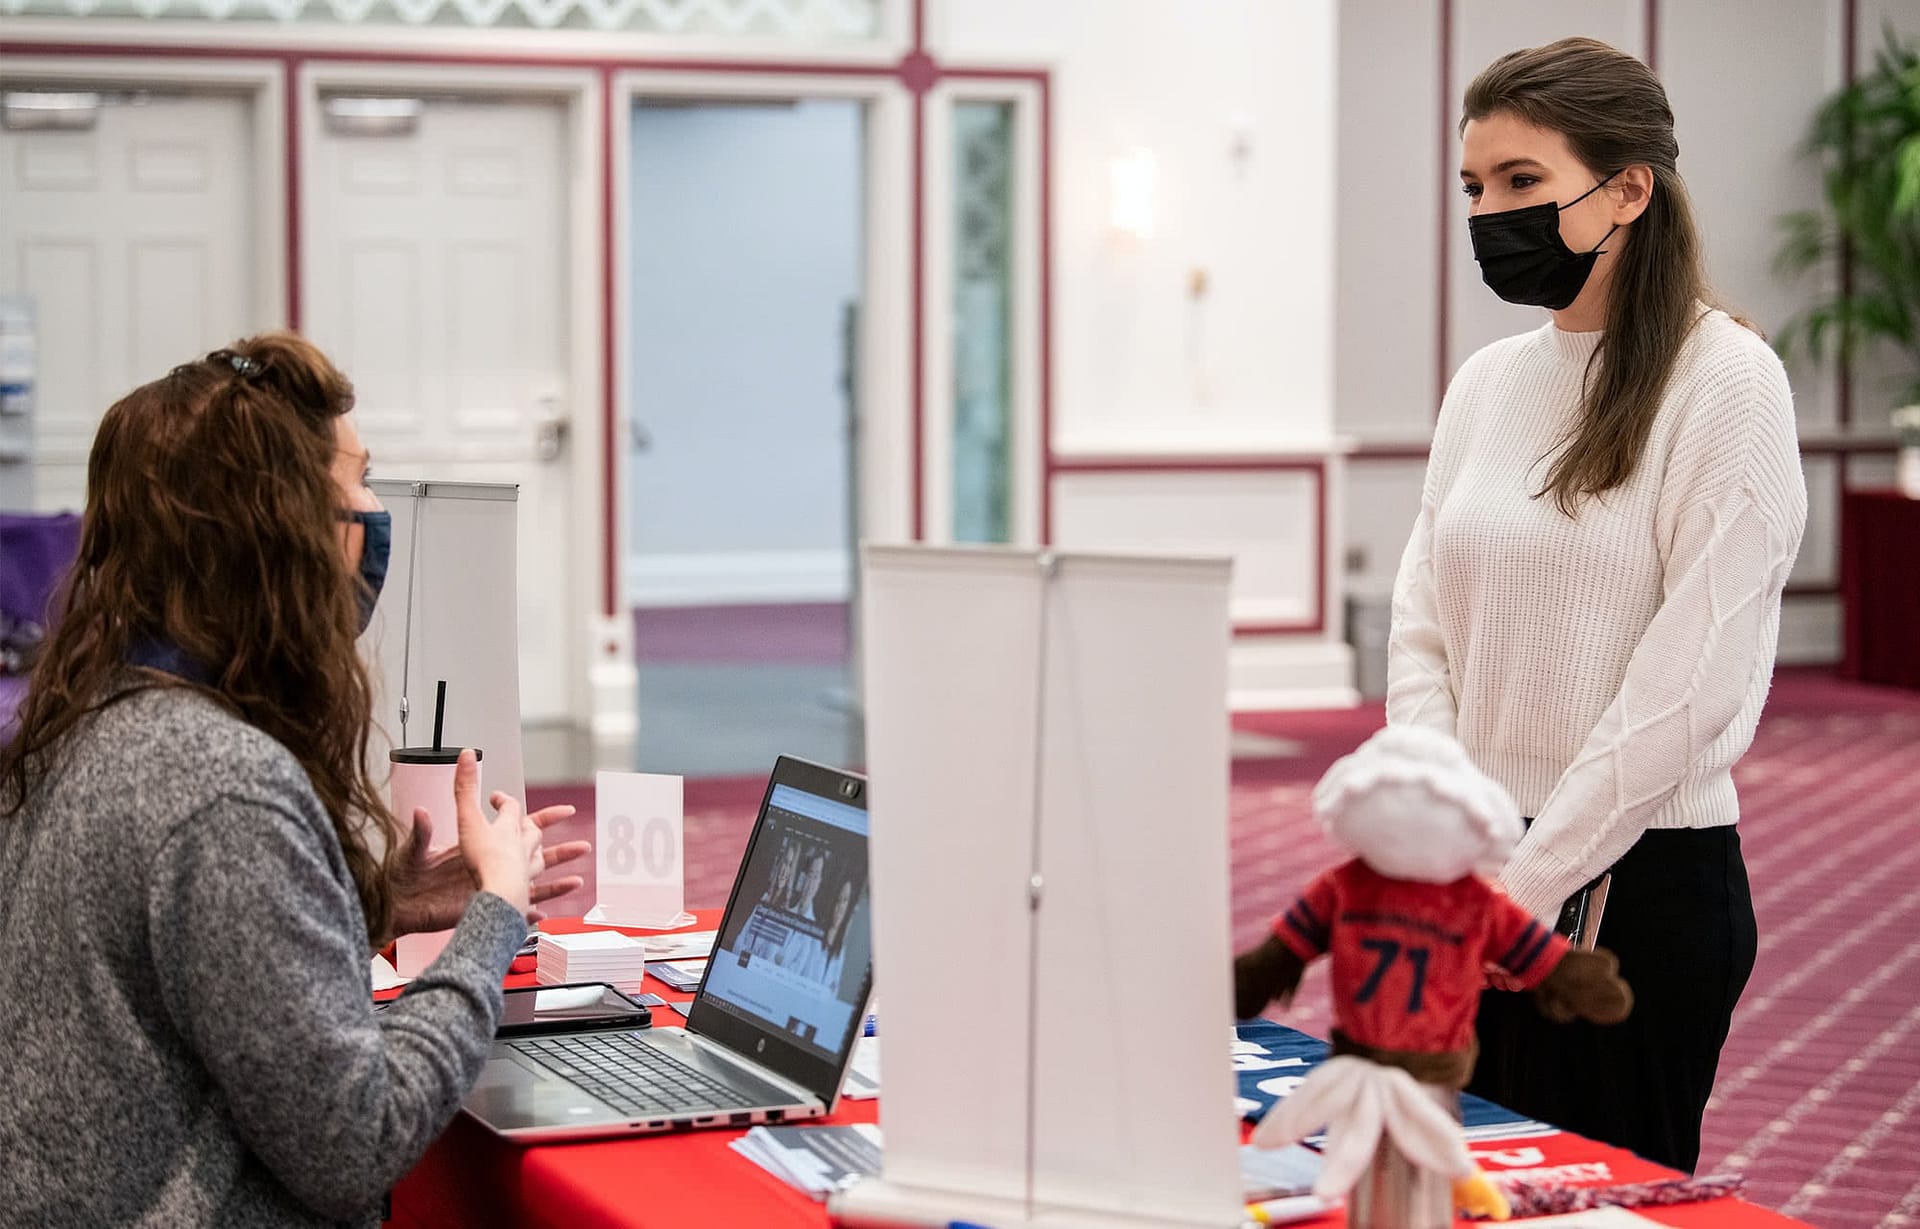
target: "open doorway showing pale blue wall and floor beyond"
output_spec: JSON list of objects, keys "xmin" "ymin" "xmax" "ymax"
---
[{"xmin": 624, "ymin": 98, "xmax": 866, "ymax": 776}]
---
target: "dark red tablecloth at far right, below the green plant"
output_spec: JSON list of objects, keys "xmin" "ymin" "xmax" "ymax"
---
[{"xmin": 1839, "ymin": 490, "xmax": 1920, "ymax": 687}]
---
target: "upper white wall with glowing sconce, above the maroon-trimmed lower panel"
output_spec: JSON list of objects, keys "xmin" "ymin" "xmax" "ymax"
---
[{"xmin": 929, "ymin": 0, "xmax": 1334, "ymax": 451}]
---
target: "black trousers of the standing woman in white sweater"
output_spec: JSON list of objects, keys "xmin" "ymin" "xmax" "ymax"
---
[{"xmin": 1467, "ymin": 826, "xmax": 1759, "ymax": 1173}]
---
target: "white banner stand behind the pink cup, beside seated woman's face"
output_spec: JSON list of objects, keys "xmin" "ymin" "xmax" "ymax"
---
[{"xmin": 361, "ymin": 478, "xmax": 526, "ymax": 843}]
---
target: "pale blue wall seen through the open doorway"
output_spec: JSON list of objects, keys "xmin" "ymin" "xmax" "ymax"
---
[{"xmin": 628, "ymin": 100, "xmax": 862, "ymax": 605}]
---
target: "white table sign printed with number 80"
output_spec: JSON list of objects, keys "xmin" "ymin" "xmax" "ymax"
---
[{"xmin": 588, "ymin": 772, "xmax": 685, "ymax": 929}]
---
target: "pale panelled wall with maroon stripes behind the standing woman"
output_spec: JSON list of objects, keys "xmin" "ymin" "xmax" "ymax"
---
[{"xmin": 1334, "ymin": 0, "xmax": 1920, "ymax": 661}]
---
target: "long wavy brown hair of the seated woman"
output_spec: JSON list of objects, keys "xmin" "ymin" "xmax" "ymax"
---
[{"xmin": 0, "ymin": 332, "xmax": 401, "ymax": 935}]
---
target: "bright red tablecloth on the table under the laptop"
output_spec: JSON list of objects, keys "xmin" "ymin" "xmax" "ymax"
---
[{"xmin": 390, "ymin": 910, "xmax": 1799, "ymax": 1229}]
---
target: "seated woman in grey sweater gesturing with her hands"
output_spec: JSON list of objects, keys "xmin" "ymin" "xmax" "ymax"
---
[{"xmin": 0, "ymin": 334, "xmax": 584, "ymax": 1225}]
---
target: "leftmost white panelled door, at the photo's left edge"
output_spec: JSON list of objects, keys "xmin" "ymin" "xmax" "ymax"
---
[{"xmin": 0, "ymin": 96, "xmax": 259, "ymax": 511}]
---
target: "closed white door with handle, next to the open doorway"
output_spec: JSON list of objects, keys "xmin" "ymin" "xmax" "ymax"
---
[{"xmin": 303, "ymin": 100, "xmax": 586, "ymax": 722}]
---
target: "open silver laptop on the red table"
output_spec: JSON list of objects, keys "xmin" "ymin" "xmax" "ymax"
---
[{"xmin": 461, "ymin": 757, "xmax": 874, "ymax": 1143}]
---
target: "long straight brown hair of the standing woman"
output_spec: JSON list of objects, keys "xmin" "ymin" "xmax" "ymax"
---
[{"xmin": 1459, "ymin": 38, "xmax": 1707, "ymax": 517}]
